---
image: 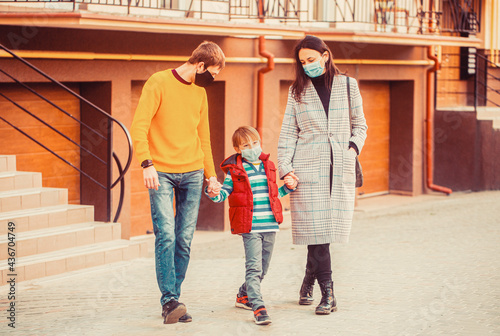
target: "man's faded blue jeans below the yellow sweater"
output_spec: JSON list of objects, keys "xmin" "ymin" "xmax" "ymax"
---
[{"xmin": 149, "ymin": 169, "xmax": 203, "ymax": 306}]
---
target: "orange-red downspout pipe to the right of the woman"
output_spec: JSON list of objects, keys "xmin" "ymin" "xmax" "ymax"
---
[{"xmin": 426, "ymin": 46, "xmax": 452, "ymax": 195}]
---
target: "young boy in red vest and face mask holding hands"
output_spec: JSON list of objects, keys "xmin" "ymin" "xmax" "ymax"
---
[{"xmin": 207, "ymin": 126, "xmax": 298, "ymax": 325}]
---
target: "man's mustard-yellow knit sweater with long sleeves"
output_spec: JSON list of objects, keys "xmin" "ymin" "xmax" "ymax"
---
[{"xmin": 130, "ymin": 69, "xmax": 215, "ymax": 178}]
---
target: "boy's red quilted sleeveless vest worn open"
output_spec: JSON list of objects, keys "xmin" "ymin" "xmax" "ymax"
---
[{"xmin": 220, "ymin": 153, "xmax": 283, "ymax": 234}]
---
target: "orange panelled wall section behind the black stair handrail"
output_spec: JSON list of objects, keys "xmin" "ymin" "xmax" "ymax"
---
[{"xmin": 0, "ymin": 83, "xmax": 80, "ymax": 204}]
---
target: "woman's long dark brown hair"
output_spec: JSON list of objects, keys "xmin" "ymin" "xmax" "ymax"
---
[{"xmin": 292, "ymin": 35, "xmax": 340, "ymax": 102}]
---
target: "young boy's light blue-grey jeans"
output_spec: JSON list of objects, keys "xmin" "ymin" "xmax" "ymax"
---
[{"xmin": 239, "ymin": 232, "xmax": 276, "ymax": 310}]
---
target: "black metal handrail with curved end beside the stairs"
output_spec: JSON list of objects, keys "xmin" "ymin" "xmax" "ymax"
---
[{"xmin": 0, "ymin": 44, "xmax": 133, "ymax": 222}]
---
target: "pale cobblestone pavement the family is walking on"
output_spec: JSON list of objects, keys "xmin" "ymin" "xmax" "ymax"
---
[{"xmin": 0, "ymin": 192, "xmax": 500, "ymax": 336}]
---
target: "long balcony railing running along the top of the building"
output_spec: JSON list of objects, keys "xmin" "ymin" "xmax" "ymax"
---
[{"xmin": 0, "ymin": 0, "xmax": 481, "ymax": 36}]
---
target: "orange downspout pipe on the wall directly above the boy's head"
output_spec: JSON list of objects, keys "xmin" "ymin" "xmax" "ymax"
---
[{"xmin": 256, "ymin": 0, "xmax": 274, "ymax": 138}]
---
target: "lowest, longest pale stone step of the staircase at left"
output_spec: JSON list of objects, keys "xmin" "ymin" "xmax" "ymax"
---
[{"xmin": 0, "ymin": 239, "xmax": 148, "ymax": 286}]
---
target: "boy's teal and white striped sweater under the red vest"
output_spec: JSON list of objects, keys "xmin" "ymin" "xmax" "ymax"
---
[{"xmin": 210, "ymin": 160, "xmax": 293, "ymax": 233}]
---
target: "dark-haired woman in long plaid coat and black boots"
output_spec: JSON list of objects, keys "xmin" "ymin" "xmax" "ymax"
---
[{"xmin": 278, "ymin": 35, "xmax": 367, "ymax": 315}]
